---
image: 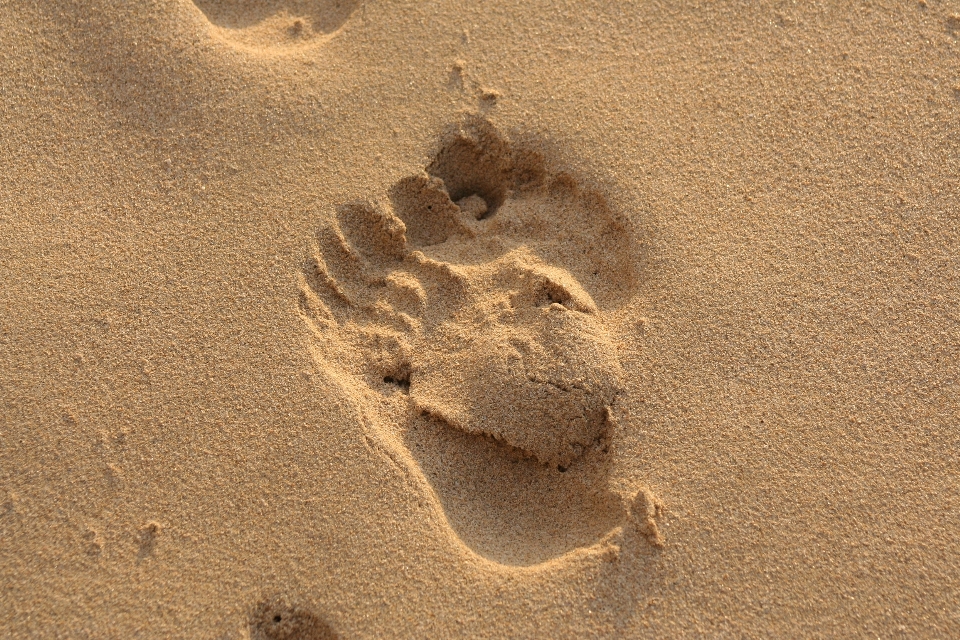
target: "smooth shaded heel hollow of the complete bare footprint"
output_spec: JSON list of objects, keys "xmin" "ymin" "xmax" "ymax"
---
[{"xmin": 404, "ymin": 412, "xmax": 624, "ymax": 566}]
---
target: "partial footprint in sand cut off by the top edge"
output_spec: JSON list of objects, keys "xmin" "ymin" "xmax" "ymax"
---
[{"xmin": 194, "ymin": 0, "xmax": 362, "ymax": 49}]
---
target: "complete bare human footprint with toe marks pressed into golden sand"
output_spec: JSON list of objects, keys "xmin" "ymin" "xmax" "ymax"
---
[{"xmin": 301, "ymin": 116, "xmax": 649, "ymax": 566}]
